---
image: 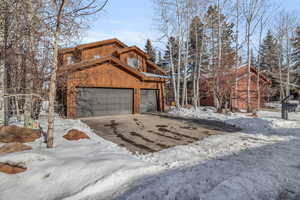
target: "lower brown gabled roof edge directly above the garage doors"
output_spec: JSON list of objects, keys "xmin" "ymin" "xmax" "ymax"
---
[{"xmin": 58, "ymin": 56, "xmax": 166, "ymax": 81}]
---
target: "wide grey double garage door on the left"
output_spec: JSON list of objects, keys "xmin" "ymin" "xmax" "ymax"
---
[{"xmin": 76, "ymin": 88, "xmax": 133, "ymax": 117}]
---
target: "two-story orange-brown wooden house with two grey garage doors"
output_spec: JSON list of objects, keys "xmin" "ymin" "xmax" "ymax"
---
[{"xmin": 58, "ymin": 39, "xmax": 167, "ymax": 118}]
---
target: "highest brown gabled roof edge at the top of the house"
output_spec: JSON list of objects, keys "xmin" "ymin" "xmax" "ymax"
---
[{"xmin": 60, "ymin": 38, "xmax": 128, "ymax": 53}]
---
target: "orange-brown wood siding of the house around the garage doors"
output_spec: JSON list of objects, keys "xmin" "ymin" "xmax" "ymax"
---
[{"xmin": 59, "ymin": 39, "xmax": 165, "ymax": 118}]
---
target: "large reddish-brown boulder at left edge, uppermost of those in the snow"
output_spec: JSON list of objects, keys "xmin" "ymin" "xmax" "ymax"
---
[{"xmin": 0, "ymin": 125, "xmax": 41, "ymax": 143}]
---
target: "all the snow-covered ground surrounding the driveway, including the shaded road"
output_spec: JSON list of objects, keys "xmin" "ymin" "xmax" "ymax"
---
[{"xmin": 0, "ymin": 108, "xmax": 300, "ymax": 200}]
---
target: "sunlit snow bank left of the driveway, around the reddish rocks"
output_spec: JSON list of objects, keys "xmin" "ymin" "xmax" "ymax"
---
[{"xmin": 0, "ymin": 115, "xmax": 160, "ymax": 200}]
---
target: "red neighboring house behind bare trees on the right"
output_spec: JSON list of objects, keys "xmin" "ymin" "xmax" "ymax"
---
[{"xmin": 201, "ymin": 64, "xmax": 271, "ymax": 110}]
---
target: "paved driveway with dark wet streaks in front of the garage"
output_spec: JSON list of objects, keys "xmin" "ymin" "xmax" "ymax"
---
[{"xmin": 81, "ymin": 114, "xmax": 239, "ymax": 154}]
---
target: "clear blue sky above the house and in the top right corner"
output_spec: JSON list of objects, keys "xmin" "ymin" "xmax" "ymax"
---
[{"xmin": 82, "ymin": 0, "xmax": 300, "ymax": 48}]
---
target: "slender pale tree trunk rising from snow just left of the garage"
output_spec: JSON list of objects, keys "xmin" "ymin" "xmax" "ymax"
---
[{"xmin": 47, "ymin": 0, "xmax": 66, "ymax": 148}]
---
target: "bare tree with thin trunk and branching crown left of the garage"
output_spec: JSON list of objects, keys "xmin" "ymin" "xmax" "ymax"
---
[{"xmin": 47, "ymin": 0, "xmax": 108, "ymax": 148}]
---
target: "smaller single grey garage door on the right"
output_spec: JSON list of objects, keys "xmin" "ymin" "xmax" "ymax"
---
[{"xmin": 140, "ymin": 89, "xmax": 158, "ymax": 113}]
